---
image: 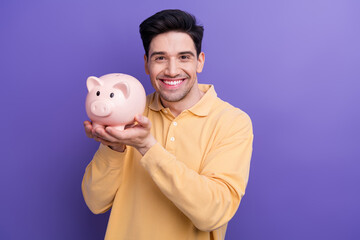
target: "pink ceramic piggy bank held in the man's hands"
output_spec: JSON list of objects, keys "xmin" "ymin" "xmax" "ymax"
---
[{"xmin": 86, "ymin": 73, "xmax": 146, "ymax": 131}]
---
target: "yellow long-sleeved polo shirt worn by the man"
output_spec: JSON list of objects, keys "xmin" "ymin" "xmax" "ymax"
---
[{"xmin": 82, "ymin": 84, "xmax": 253, "ymax": 240}]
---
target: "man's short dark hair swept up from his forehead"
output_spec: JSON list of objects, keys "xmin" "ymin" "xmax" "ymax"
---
[{"xmin": 139, "ymin": 9, "xmax": 204, "ymax": 57}]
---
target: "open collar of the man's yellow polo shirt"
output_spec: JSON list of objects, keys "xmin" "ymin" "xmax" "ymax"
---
[{"xmin": 149, "ymin": 84, "xmax": 217, "ymax": 116}]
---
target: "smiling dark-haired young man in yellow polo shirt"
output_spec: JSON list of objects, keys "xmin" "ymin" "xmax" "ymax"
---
[{"xmin": 82, "ymin": 10, "xmax": 253, "ymax": 240}]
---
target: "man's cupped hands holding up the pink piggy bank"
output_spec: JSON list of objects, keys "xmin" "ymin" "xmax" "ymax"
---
[{"xmin": 84, "ymin": 115, "xmax": 156, "ymax": 155}]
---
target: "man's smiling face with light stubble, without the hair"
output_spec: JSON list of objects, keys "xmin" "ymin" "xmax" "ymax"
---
[{"xmin": 144, "ymin": 32, "xmax": 205, "ymax": 102}]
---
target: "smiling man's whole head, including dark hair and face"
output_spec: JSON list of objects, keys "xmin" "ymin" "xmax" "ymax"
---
[{"xmin": 140, "ymin": 10, "xmax": 205, "ymax": 107}]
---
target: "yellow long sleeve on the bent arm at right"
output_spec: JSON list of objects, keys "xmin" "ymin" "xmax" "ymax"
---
[{"xmin": 141, "ymin": 113, "xmax": 253, "ymax": 231}]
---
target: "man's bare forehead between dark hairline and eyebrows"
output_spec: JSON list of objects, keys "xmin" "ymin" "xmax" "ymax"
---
[{"xmin": 149, "ymin": 31, "xmax": 196, "ymax": 54}]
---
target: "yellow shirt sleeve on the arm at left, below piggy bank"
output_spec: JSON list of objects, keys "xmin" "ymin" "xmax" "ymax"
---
[{"xmin": 81, "ymin": 144, "xmax": 127, "ymax": 214}]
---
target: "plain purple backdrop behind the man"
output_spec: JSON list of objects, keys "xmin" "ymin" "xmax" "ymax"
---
[{"xmin": 0, "ymin": 0, "xmax": 360, "ymax": 240}]
